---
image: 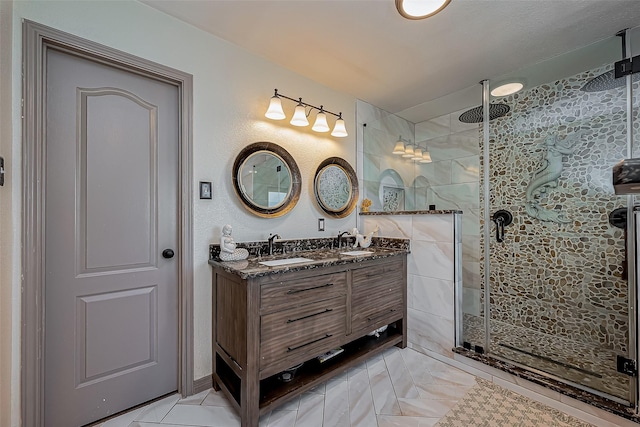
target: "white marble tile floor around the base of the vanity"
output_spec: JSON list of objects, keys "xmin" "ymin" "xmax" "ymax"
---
[{"xmin": 96, "ymin": 347, "xmax": 596, "ymax": 427}]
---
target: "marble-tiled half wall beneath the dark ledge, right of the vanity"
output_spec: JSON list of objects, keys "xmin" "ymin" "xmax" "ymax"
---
[{"xmin": 362, "ymin": 214, "xmax": 463, "ymax": 358}]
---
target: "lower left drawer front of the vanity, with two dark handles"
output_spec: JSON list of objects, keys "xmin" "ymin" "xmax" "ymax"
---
[{"xmin": 260, "ymin": 296, "xmax": 346, "ymax": 376}]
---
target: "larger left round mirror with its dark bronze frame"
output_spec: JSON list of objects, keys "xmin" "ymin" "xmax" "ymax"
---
[{"xmin": 232, "ymin": 142, "xmax": 301, "ymax": 218}]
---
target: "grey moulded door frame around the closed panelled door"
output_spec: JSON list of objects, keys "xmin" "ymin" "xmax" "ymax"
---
[{"xmin": 21, "ymin": 20, "xmax": 194, "ymax": 427}]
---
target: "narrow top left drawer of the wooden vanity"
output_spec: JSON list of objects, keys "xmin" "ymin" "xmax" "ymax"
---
[{"xmin": 260, "ymin": 272, "xmax": 347, "ymax": 312}]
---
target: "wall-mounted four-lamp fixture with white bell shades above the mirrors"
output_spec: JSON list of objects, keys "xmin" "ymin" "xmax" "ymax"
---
[{"xmin": 264, "ymin": 89, "xmax": 349, "ymax": 138}]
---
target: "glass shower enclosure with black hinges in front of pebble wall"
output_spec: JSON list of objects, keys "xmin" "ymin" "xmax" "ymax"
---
[{"xmin": 457, "ymin": 29, "xmax": 640, "ymax": 406}]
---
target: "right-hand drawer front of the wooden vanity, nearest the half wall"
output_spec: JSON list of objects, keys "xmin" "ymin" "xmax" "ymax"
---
[{"xmin": 351, "ymin": 262, "xmax": 405, "ymax": 332}]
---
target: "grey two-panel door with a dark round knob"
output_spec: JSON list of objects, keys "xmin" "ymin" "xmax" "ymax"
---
[{"xmin": 44, "ymin": 49, "xmax": 180, "ymax": 426}]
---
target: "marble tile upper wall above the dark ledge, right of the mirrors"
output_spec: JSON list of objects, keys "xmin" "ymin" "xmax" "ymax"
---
[{"xmin": 358, "ymin": 102, "xmax": 480, "ymax": 217}]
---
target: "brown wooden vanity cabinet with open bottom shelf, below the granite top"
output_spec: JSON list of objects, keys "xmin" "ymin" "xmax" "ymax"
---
[{"xmin": 212, "ymin": 254, "xmax": 407, "ymax": 427}]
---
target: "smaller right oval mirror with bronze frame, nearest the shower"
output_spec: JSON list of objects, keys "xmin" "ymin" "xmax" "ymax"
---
[{"xmin": 313, "ymin": 157, "xmax": 358, "ymax": 218}]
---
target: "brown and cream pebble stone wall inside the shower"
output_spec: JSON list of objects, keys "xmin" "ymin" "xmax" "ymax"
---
[{"xmin": 464, "ymin": 67, "xmax": 629, "ymax": 399}]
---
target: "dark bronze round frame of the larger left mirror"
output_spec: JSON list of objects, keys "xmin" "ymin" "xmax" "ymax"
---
[{"xmin": 231, "ymin": 141, "xmax": 302, "ymax": 218}]
